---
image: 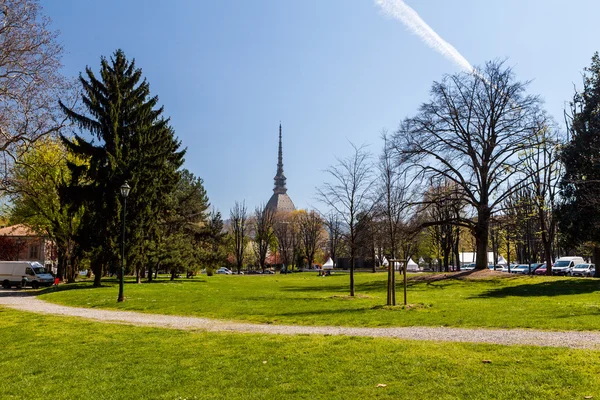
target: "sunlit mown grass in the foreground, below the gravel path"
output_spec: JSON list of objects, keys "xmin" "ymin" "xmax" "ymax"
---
[{"xmin": 0, "ymin": 308, "xmax": 600, "ymax": 399}]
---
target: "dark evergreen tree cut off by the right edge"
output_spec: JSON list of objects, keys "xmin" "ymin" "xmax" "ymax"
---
[{"xmin": 559, "ymin": 53, "xmax": 600, "ymax": 274}]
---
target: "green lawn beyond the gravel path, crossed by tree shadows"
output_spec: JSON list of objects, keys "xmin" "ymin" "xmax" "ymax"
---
[{"xmin": 34, "ymin": 273, "xmax": 600, "ymax": 330}]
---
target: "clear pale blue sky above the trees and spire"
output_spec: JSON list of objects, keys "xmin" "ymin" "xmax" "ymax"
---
[{"xmin": 41, "ymin": 0, "xmax": 600, "ymax": 218}]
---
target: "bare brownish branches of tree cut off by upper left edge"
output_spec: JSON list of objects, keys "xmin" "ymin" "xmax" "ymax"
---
[{"xmin": 0, "ymin": 0, "xmax": 73, "ymax": 192}]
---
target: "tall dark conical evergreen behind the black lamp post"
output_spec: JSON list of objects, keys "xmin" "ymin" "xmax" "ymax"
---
[{"xmin": 61, "ymin": 50, "xmax": 185, "ymax": 285}]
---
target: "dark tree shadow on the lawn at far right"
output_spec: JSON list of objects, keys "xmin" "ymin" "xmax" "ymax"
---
[{"xmin": 471, "ymin": 278, "xmax": 600, "ymax": 299}]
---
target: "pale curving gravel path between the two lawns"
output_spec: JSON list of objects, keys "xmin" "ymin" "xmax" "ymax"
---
[{"xmin": 0, "ymin": 292, "xmax": 600, "ymax": 349}]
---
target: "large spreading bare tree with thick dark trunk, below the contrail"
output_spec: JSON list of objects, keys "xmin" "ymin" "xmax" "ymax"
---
[{"xmin": 394, "ymin": 62, "xmax": 543, "ymax": 269}]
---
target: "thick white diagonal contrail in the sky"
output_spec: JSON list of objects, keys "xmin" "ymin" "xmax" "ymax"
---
[{"xmin": 375, "ymin": 0, "xmax": 473, "ymax": 72}]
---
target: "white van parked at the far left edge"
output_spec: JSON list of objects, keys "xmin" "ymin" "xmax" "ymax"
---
[{"xmin": 0, "ymin": 261, "xmax": 54, "ymax": 289}]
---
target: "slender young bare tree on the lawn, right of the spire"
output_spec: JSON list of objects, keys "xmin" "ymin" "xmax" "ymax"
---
[{"xmin": 318, "ymin": 143, "xmax": 374, "ymax": 296}]
